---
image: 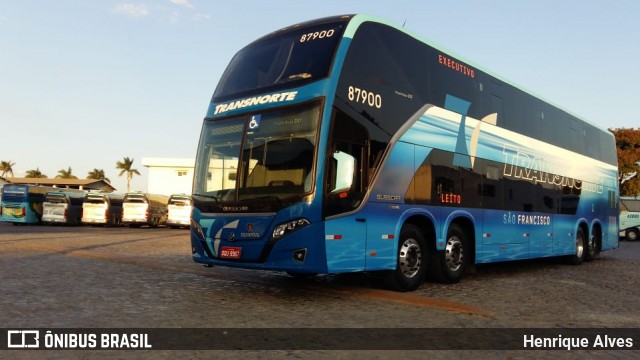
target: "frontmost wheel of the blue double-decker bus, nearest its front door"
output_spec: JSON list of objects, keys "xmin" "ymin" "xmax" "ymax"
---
[{"xmin": 387, "ymin": 224, "xmax": 427, "ymax": 291}]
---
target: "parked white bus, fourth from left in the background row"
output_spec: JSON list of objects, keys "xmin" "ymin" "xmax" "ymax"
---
[{"xmin": 122, "ymin": 192, "xmax": 169, "ymax": 227}]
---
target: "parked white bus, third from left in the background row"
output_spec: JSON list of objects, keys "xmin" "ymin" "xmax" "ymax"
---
[{"xmin": 82, "ymin": 193, "xmax": 124, "ymax": 226}]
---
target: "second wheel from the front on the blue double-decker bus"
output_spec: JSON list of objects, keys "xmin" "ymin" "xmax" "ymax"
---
[{"xmin": 431, "ymin": 224, "xmax": 471, "ymax": 284}]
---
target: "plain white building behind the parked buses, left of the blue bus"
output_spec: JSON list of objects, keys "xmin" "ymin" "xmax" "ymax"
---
[{"xmin": 141, "ymin": 157, "xmax": 195, "ymax": 195}]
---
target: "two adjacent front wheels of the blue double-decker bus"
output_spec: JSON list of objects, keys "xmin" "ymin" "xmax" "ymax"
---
[{"xmin": 388, "ymin": 224, "xmax": 469, "ymax": 291}]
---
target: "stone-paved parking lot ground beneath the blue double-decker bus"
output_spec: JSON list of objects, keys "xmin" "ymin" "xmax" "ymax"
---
[{"xmin": 0, "ymin": 223, "xmax": 640, "ymax": 358}]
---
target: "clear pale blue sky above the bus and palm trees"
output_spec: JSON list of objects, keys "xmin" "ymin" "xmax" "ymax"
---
[{"xmin": 0, "ymin": 0, "xmax": 640, "ymax": 191}]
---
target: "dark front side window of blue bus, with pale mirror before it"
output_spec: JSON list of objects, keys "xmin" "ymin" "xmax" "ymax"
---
[{"xmin": 324, "ymin": 109, "xmax": 370, "ymax": 216}]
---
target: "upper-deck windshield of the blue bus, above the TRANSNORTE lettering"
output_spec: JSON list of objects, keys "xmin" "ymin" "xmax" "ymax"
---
[{"xmin": 212, "ymin": 19, "xmax": 346, "ymax": 102}]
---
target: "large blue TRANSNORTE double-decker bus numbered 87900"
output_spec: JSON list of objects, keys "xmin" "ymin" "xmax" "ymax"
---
[{"xmin": 191, "ymin": 15, "xmax": 618, "ymax": 291}]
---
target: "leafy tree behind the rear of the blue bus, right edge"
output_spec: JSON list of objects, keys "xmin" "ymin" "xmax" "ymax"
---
[{"xmin": 610, "ymin": 128, "xmax": 640, "ymax": 196}]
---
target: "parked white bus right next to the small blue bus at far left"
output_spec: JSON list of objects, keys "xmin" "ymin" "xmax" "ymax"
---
[{"xmin": 42, "ymin": 189, "xmax": 85, "ymax": 225}]
